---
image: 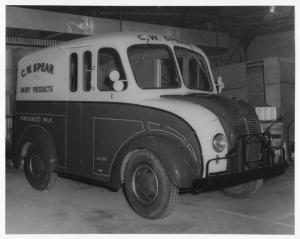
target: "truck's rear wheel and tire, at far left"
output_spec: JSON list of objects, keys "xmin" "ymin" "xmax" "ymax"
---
[{"xmin": 24, "ymin": 144, "xmax": 57, "ymax": 191}]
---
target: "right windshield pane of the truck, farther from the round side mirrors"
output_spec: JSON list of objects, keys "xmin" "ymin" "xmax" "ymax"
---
[{"xmin": 175, "ymin": 47, "xmax": 213, "ymax": 91}]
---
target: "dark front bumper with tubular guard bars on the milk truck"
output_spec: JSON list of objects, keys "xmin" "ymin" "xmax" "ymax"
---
[{"xmin": 193, "ymin": 132, "xmax": 289, "ymax": 191}]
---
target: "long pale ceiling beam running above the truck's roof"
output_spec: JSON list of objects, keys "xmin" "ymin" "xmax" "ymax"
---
[{"xmin": 6, "ymin": 7, "xmax": 230, "ymax": 49}]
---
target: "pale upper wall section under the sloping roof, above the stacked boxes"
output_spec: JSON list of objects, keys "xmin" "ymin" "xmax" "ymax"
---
[{"xmin": 247, "ymin": 31, "xmax": 295, "ymax": 60}]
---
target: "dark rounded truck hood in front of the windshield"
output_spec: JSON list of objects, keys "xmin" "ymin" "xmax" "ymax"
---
[{"xmin": 161, "ymin": 93, "xmax": 260, "ymax": 148}]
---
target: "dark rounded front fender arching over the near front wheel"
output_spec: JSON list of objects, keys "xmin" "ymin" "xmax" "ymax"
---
[{"xmin": 110, "ymin": 135, "xmax": 196, "ymax": 190}]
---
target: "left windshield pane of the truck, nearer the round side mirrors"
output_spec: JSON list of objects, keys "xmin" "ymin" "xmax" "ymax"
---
[{"xmin": 128, "ymin": 44, "xmax": 180, "ymax": 89}]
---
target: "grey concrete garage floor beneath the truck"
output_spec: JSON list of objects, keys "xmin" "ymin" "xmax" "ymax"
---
[{"xmin": 6, "ymin": 162, "xmax": 294, "ymax": 234}]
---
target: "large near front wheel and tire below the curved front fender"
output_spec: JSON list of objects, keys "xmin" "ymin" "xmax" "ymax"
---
[{"xmin": 124, "ymin": 149, "xmax": 178, "ymax": 219}]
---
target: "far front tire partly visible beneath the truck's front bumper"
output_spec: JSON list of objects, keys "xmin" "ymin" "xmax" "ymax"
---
[{"xmin": 222, "ymin": 179, "xmax": 263, "ymax": 198}]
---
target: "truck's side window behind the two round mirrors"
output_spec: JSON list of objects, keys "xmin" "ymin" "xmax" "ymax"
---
[{"xmin": 97, "ymin": 48, "xmax": 127, "ymax": 91}]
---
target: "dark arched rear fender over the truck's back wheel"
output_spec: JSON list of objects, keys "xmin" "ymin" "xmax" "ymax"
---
[{"xmin": 14, "ymin": 125, "xmax": 57, "ymax": 170}]
